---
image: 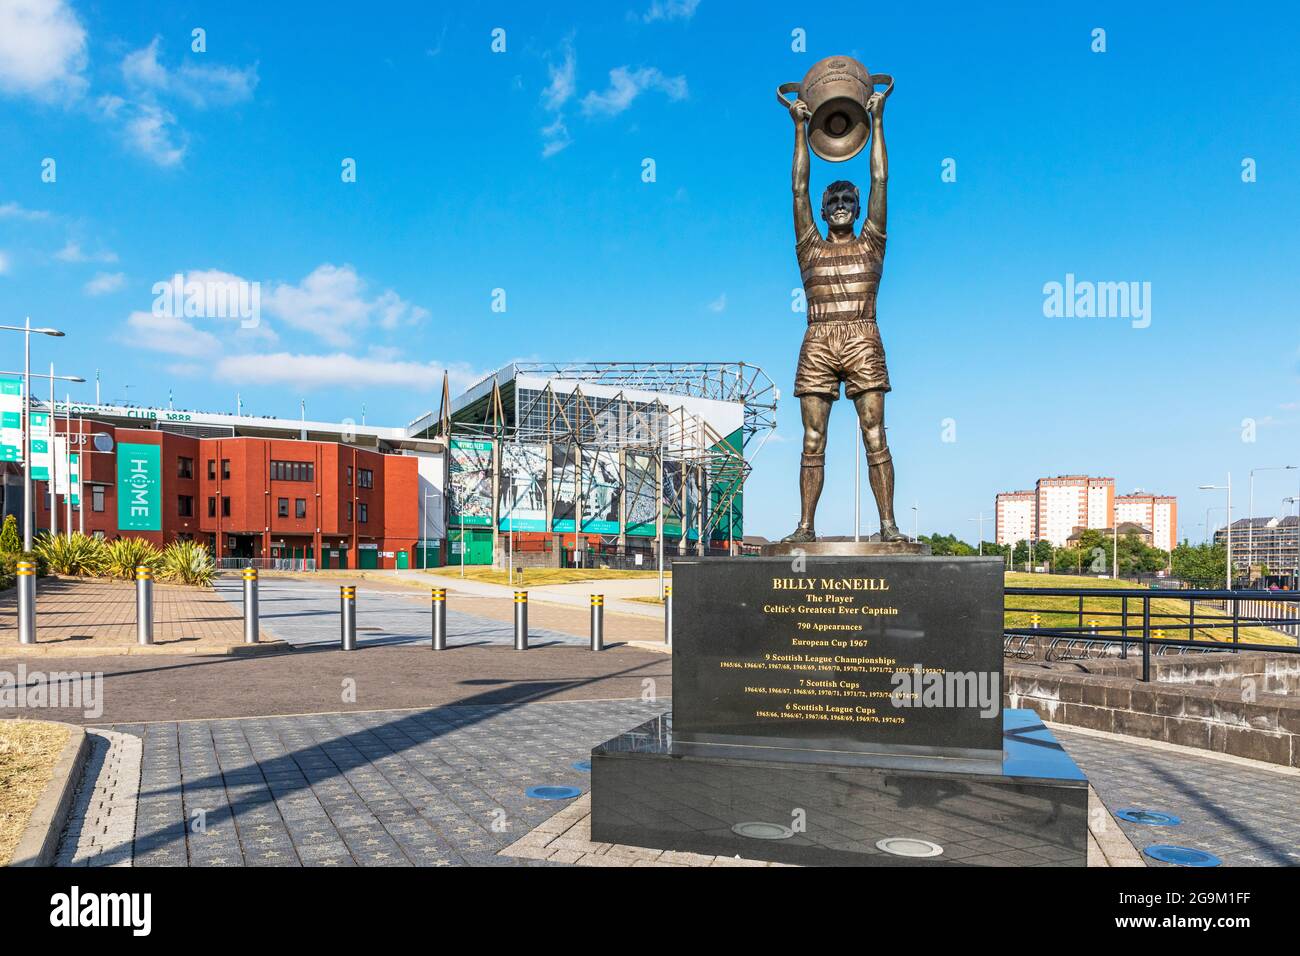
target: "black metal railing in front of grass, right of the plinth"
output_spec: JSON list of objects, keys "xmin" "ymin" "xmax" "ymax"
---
[{"xmin": 1002, "ymin": 588, "xmax": 1300, "ymax": 680}]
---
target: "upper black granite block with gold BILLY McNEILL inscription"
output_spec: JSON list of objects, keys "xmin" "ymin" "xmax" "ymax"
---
[{"xmin": 672, "ymin": 555, "xmax": 1002, "ymax": 762}]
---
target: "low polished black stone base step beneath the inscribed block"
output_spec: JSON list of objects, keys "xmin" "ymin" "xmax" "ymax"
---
[{"xmin": 592, "ymin": 710, "xmax": 1088, "ymax": 866}]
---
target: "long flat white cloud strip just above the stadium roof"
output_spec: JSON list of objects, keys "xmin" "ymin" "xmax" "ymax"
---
[{"xmin": 216, "ymin": 352, "xmax": 468, "ymax": 392}]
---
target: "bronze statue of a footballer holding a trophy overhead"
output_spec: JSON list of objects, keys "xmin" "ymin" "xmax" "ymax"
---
[{"xmin": 783, "ymin": 57, "xmax": 904, "ymax": 542}]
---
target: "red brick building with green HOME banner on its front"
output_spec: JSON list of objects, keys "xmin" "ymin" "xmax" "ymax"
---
[{"xmin": 34, "ymin": 419, "xmax": 420, "ymax": 568}]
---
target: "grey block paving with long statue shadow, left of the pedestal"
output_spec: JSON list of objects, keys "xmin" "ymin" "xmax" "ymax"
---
[{"xmin": 61, "ymin": 700, "xmax": 666, "ymax": 866}]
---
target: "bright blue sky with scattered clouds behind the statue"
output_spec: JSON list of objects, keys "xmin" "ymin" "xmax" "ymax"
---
[{"xmin": 0, "ymin": 0, "xmax": 1300, "ymax": 540}]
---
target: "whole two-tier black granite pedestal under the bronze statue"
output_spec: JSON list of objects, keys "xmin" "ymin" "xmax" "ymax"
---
[{"xmin": 592, "ymin": 554, "xmax": 1088, "ymax": 866}]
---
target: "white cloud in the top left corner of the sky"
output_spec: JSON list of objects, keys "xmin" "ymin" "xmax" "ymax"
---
[{"xmin": 0, "ymin": 0, "xmax": 86, "ymax": 101}]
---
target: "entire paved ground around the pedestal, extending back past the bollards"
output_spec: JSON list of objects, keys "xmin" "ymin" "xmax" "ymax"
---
[{"xmin": 0, "ymin": 579, "xmax": 1300, "ymax": 866}]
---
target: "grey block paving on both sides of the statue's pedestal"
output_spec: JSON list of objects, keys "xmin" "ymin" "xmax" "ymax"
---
[{"xmin": 48, "ymin": 698, "xmax": 1300, "ymax": 866}]
